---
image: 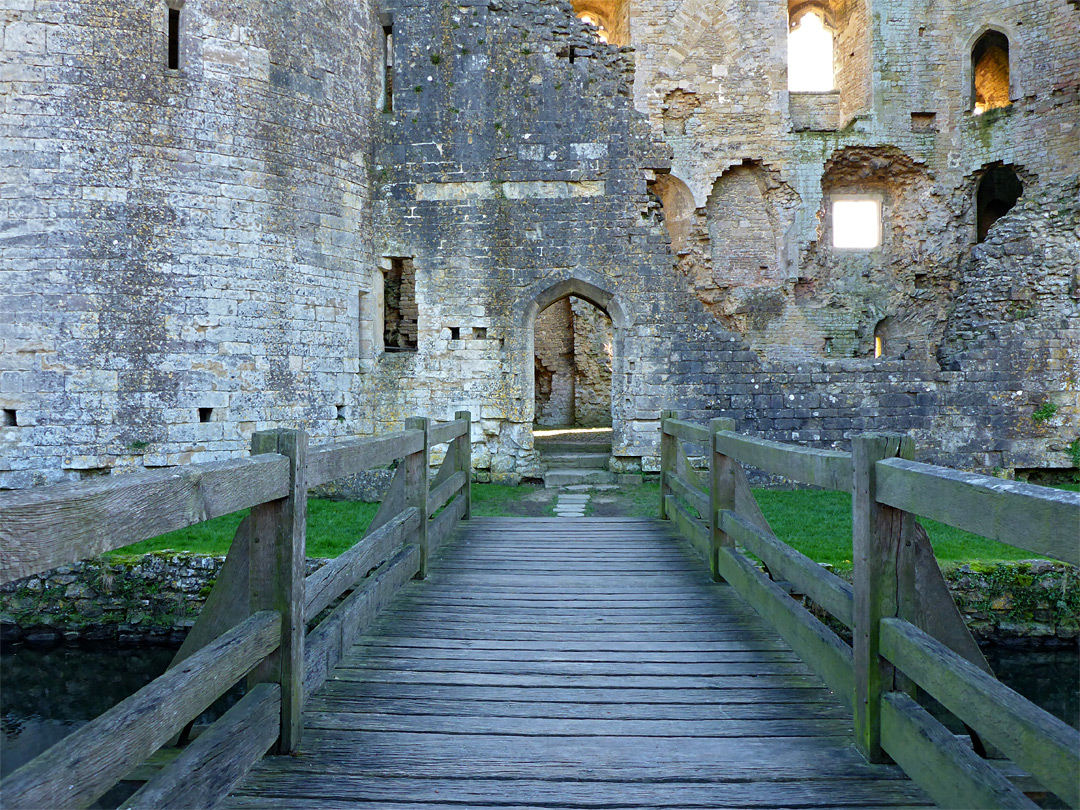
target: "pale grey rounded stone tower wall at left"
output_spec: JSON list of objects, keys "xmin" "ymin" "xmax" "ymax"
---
[{"xmin": 0, "ymin": 0, "xmax": 377, "ymax": 486}]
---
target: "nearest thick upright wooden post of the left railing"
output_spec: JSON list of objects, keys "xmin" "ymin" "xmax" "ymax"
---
[{"xmin": 247, "ymin": 430, "xmax": 308, "ymax": 754}]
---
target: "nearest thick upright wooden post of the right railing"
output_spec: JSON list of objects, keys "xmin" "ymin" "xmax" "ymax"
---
[{"xmin": 851, "ymin": 433, "xmax": 915, "ymax": 762}]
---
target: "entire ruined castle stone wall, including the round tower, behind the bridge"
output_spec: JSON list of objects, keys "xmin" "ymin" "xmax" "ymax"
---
[{"xmin": 0, "ymin": 0, "xmax": 1080, "ymax": 487}]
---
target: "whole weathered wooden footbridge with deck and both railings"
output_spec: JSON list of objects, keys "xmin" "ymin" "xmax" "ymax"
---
[{"xmin": 0, "ymin": 411, "xmax": 1080, "ymax": 810}]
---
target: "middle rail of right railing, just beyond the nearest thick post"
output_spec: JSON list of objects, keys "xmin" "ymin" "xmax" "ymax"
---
[{"xmin": 720, "ymin": 511, "xmax": 854, "ymax": 627}]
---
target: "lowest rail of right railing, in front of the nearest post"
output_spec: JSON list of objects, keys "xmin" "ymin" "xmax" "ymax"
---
[{"xmin": 881, "ymin": 692, "xmax": 1037, "ymax": 810}]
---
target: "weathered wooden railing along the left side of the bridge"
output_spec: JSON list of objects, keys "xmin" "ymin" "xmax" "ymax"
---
[{"xmin": 0, "ymin": 411, "xmax": 472, "ymax": 810}]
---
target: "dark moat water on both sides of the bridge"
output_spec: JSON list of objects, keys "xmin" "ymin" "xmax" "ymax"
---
[{"xmin": 0, "ymin": 647, "xmax": 1080, "ymax": 775}]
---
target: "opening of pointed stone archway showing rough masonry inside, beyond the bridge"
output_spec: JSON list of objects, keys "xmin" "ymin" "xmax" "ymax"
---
[{"xmin": 534, "ymin": 296, "xmax": 613, "ymax": 428}]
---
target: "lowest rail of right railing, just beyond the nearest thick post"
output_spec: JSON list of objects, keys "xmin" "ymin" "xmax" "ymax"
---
[{"xmin": 718, "ymin": 549, "xmax": 854, "ymax": 706}]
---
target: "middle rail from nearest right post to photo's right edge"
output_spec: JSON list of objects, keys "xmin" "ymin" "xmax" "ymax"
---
[{"xmin": 881, "ymin": 619, "xmax": 1080, "ymax": 807}]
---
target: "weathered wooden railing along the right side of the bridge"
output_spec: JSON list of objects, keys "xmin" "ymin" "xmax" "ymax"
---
[{"xmin": 660, "ymin": 410, "xmax": 1080, "ymax": 808}]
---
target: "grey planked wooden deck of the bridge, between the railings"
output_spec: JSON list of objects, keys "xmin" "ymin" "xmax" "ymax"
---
[{"xmin": 226, "ymin": 518, "xmax": 931, "ymax": 810}]
